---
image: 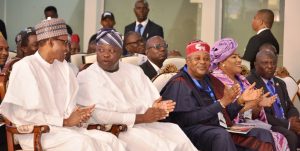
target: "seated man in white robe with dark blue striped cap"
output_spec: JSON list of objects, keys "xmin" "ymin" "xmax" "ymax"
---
[{"xmin": 76, "ymin": 30, "xmax": 197, "ymax": 151}]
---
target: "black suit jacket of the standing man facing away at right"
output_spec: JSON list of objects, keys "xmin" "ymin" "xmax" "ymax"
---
[{"xmin": 243, "ymin": 29, "xmax": 279, "ymax": 69}]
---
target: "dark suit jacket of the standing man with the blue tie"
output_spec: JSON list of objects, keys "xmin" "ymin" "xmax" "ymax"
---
[{"xmin": 124, "ymin": 20, "xmax": 164, "ymax": 40}]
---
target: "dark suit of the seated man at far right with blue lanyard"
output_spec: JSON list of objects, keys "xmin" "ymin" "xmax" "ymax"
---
[{"xmin": 247, "ymin": 71, "xmax": 300, "ymax": 150}]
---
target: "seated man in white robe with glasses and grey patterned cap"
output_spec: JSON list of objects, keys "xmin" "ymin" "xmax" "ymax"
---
[{"xmin": 0, "ymin": 18, "xmax": 125, "ymax": 151}]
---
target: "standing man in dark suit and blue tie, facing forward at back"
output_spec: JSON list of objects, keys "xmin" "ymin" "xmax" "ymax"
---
[{"xmin": 124, "ymin": 0, "xmax": 164, "ymax": 40}]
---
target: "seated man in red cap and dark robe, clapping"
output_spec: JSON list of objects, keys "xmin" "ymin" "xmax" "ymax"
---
[{"xmin": 161, "ymin": 41, "xmax": 273, "ymax": 151}]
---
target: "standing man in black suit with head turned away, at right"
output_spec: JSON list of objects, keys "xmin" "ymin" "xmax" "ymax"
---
[{"xmin": 243, "ymin": 9, "xmax": 279, "ymax": 69}]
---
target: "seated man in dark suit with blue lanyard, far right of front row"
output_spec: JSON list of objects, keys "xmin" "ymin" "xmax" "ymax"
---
[{"xmin": 247, "ymin": 48, "xmax": 300, "ymax": 151}]
